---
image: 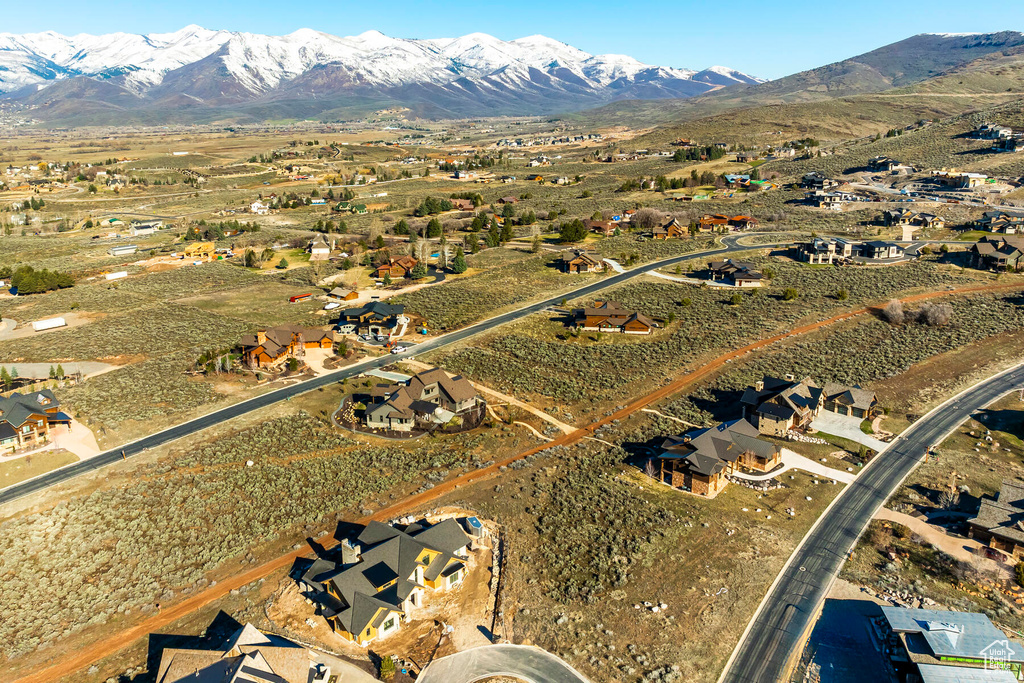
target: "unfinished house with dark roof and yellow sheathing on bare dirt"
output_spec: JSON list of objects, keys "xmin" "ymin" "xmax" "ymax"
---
[{"xmin": 301, "ymin": 519, "xmax": 470, "ymax": 647}]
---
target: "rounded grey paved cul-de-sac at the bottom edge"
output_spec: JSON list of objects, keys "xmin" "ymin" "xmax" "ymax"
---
[{"xmin": 417, "ymin": 645, "xmax": 588, "ymax": 683}]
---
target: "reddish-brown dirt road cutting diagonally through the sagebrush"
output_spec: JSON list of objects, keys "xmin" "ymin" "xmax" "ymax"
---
[{"xmin": 12, "ymin": 283, "xmax": 1024, "ymax": 683}]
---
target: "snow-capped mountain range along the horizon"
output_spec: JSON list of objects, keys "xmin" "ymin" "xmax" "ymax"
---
[{"xmin": 0, "ymin": 26, "xmax": 761, "ymax": 123}]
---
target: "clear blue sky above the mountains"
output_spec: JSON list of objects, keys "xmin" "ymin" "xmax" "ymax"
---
[{"xmin": 6, "ymin": 0, "xmax": 1024, "ymax": 78}]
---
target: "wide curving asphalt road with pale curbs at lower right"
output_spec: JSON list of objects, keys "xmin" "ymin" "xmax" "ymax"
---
[{"xmin": 720, "ymin": 367, "xmax": 1024, "ymax": 683}]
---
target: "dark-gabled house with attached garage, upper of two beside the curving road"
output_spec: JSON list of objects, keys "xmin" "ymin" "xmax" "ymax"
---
[{"xmin": 739, "ymin": 376, "xmax": 878, "ymax": 436}]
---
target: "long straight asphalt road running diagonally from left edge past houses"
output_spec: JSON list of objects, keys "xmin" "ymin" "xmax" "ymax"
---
[{"xmin": 0, "ymin": 237, "xmax": 757, "ymax": 505}]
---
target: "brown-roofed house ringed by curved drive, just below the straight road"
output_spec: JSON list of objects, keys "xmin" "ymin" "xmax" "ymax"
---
[{"xmin": 365, "ymin": 368, "xmax": 483, "ymax": 432}]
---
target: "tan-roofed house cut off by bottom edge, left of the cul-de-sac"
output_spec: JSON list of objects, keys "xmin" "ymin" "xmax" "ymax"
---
[{"xmin": 156, "ymin": 624, "xmax": 323, "ymax": 683}]
